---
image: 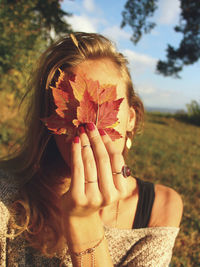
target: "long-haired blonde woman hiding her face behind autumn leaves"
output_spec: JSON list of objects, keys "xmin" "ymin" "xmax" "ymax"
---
[{"xmin": 0, "ymin": 33, "xmax": 182, "ymax": 267}]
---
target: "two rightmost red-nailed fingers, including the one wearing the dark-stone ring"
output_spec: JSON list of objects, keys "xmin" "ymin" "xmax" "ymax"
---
[{"xmin": 84, "ymin": 125, "xmax": 127, "ymax": 202}]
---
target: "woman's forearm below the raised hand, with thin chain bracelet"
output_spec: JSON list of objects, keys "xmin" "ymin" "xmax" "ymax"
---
[{"xmin": 65, "ymin": 214, "xmax": 113, "ymax": 267}]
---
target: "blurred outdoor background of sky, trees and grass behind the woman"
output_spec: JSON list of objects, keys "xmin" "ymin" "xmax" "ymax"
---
[{"xmin": 0, "ymin": 0, "xmax": 200, "ymax": 267}]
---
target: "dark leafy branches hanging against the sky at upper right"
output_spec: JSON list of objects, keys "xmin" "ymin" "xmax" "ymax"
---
[{"xmin": 121, "ymin": 0, "xmax": 200, "ymax": 78}]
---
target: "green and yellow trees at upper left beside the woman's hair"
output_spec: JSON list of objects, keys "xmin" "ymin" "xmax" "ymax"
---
[{"xmin": 0, "ymin": 0, "xmax": 71, "ymax": 96}]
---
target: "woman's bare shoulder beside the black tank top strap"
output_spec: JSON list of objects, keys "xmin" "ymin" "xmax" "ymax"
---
[{"xmin": 149, "ymin": 184, "xmax": 183, "ymax": 227}]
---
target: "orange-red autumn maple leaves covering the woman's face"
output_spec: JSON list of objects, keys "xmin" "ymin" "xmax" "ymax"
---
[{"xmin": 41, "ymin": 69, "xmax": 124, "ymax": 140}]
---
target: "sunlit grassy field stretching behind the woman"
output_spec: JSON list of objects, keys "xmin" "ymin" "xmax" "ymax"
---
[{"xmin": 0, "ymin": 110, "xmax": 200, "ymax": 267}]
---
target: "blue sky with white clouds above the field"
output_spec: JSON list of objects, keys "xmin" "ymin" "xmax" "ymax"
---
[{"xmin": 61, "ymin": 0, "xmax": 200, "ymax": 110}]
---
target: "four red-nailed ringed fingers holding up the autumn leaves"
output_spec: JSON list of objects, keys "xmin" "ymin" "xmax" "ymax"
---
[{"xmin": 71, "ymin": 124, "xmax": 126, "ymax": 209}]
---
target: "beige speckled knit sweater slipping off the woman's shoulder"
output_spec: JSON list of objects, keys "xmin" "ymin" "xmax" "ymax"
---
[{"xmin": 0, "ymin": 170, "xmax": 179, "ymax": 267}]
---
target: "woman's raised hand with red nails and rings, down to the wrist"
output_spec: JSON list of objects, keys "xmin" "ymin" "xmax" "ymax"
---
[{"xmin": 62, "ymin": 123, "xmax": 127, "ymax": 217}]
